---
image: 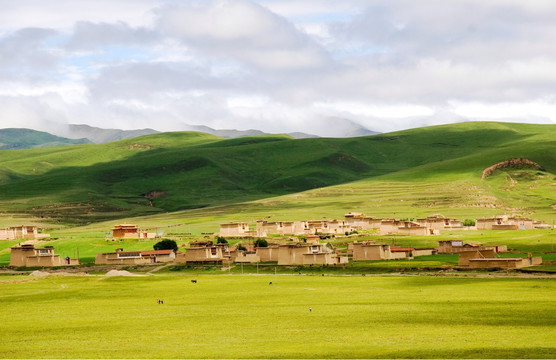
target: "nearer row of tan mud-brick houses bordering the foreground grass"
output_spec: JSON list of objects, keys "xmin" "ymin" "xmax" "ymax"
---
[{"xmin": 10, "ymin": 235, "xmax": 542, "ymax": 269}]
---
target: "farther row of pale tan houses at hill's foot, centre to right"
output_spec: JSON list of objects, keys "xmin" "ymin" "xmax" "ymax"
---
[{"xmin": 223, "ymin": 212, "xmax": 548, "ymax": 237}]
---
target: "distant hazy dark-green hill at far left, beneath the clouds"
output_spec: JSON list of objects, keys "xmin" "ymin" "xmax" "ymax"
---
[{"xmin": 0, "ymin": 129, "xmax": 90, "ymax": 150}]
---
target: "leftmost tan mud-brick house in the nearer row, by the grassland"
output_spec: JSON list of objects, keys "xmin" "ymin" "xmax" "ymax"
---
[{"xmin": 10, "ymin": 244, "xmax": 79, "ymax": 267}]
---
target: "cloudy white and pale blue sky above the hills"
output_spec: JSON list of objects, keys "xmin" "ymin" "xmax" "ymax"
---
[{"xmin": 0, "ymin": 0, "xmax": 556, "ymax": 136}]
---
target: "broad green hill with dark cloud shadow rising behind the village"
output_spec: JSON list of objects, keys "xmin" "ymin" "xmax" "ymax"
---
[{"xmin": 0, "ymin": 122, "xmax": 556, "ymax": 224}]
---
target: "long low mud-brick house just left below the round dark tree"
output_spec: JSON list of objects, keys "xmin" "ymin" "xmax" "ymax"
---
[{"xmin": 95, "ymin": 248, "xmax": 176, "ymax": 265}]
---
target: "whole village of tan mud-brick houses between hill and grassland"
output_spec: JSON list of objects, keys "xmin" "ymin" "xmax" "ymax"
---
[{"xmin": 4, "ymin": 212, "xmax": 550, "ymax": 269}]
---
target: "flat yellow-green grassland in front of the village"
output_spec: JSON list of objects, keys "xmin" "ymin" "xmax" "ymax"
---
[{"xmin": 0, "ymin": 275, "xmax": 556, "ymax": 358}]
